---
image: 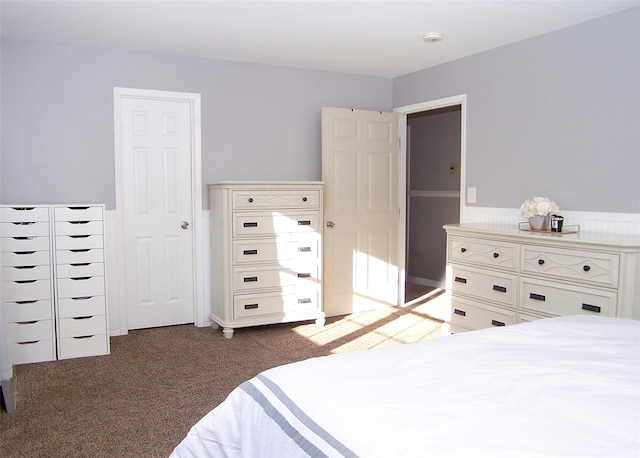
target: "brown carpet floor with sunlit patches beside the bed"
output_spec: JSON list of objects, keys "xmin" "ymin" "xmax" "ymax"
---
[{"xmin": 0, "ymin": 297, "xmax": 442, "ymax": 458}]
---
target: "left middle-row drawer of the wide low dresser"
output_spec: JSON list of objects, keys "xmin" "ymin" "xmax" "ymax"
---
[{"xmin": 451, "ymin": 265, "xmax": 518, "ymax": 307}]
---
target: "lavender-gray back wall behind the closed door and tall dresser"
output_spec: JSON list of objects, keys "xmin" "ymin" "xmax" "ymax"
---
[{"xmin": 0, "ymin": 39, "xmax": 392, "ymax": 209}]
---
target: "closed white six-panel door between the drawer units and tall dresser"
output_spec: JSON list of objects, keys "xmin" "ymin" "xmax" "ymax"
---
[{"xmin": 118, "ymin": 97, "xmax": 195, "ymax": 329}]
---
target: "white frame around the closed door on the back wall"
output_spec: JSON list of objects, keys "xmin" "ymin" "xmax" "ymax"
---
[{"xmin": 113, "ymin": 87, "xmax": 208, "ymax": 334}]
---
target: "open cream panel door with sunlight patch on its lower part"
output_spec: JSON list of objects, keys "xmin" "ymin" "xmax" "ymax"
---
[{"xmin": 322, "ymin": 108, "xmax": 399, "ymax": 316}]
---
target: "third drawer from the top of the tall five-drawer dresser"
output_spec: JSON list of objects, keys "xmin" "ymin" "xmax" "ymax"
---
[{"xmin": 233, "ymin": 237, "xmax": 320, "ymax": 264}]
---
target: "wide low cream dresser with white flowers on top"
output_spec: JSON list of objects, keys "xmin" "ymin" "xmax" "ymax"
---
[{"xmin": 444, "ymin": 224, "xmax": 640, "ymax": 332}]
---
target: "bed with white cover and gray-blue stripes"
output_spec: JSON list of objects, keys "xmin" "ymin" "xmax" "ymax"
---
[{"xmin": 172, "ymin": 316, "xmax": 640, "ymax": 458}]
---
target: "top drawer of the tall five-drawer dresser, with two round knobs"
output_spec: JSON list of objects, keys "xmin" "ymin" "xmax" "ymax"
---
[{"xmin": 232, "ymin": 189, "xmax": 320, "ymax": 210}]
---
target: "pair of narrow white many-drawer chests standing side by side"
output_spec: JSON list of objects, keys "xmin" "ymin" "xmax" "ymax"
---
[{"xmin": 0, "ymin": 205, "xmax": 109, "ymax": 364}]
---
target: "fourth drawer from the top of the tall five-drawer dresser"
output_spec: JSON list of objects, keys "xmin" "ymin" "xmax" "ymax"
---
[{"xmin": 233, "ymin": 263, "xmax": 320, "ymax": 291}]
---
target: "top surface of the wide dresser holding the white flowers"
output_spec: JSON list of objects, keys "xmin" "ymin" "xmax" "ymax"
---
[{"xmin": 444, "ymin": 223, "xmax": 640, "ymax": 251}]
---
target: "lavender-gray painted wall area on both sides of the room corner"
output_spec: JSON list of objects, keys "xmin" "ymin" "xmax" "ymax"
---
[{"xmin": 0, "ymin": 8, "xmax": 640, "ymax": 213}]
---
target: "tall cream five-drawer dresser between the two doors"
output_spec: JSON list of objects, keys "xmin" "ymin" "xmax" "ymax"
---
[{"xmin": 209, "ymin": 182, "xmax": 325, "ymax": 338}]
